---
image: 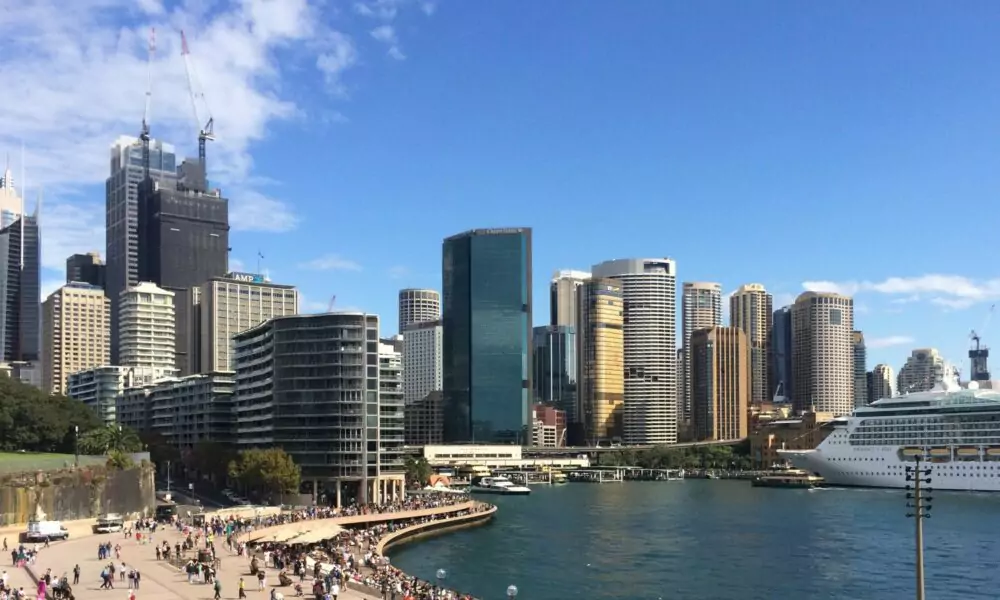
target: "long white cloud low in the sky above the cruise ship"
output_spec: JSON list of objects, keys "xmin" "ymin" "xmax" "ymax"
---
[{"xmin": 802, "ymin": 274, "xmax": 1000, "ymax": 309}]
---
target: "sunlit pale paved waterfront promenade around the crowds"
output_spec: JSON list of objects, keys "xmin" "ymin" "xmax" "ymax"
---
[{"xmin": 5, "ymin": 501, "xmax": 492, "ymax": 600}]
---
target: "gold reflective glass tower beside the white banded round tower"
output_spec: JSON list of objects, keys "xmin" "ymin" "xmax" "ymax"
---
[{"xmin": 567, "ymin": 279, "xmax": 625, "ymax": 446}]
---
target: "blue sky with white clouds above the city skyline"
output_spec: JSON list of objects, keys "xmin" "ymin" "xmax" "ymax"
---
[{"xmin": 0, "ymin": 0, "xmax": 1000, "ymax": 371}]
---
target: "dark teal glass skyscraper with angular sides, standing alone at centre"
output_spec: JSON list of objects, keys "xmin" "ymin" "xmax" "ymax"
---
[{"xmin": 441, "ymin": 227, "xmax": 532, "ymax": 445}]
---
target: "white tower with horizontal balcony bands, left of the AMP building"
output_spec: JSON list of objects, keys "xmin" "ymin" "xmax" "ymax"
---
[{"xmin": 119, "ymin": 281, "xmax": 176, "ymax": 374}]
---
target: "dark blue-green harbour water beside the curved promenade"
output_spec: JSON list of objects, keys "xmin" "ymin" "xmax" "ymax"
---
[{"xmin": 390, "ymin": 480, "xmax": 1000, "ymax": 600}]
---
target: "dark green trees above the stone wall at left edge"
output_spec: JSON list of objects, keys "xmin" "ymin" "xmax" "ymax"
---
[{"xmin": 0, "ymin": 377, "xmax": 101, "ymax": 454}]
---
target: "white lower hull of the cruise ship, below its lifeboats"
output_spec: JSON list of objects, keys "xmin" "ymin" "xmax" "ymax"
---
[{"xmin": 778, "ymin": 444, "xmax": 1000, "ymax": 492}]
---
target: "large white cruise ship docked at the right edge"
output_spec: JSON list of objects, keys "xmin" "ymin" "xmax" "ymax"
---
[{"xmin": 778, "ymin": 378, "xmax": 1000, "ymax": 492}]
